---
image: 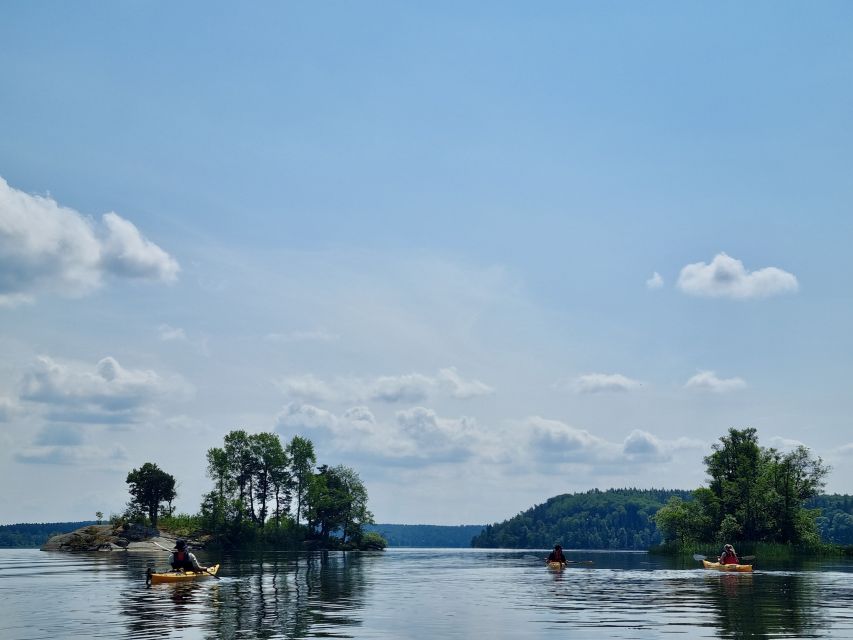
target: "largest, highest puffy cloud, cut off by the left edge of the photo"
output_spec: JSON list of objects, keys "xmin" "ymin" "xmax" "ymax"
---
[{"xmin": 0, "ymin": 178, "xmax": 179, "ymax": 306}]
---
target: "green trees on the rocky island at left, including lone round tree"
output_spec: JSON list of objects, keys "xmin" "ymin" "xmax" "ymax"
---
[{"xmin": 124, "ymin": 429, "xmax": 386, "ymax": 549}]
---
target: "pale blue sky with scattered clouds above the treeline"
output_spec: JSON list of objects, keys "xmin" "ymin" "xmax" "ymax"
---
[{"xmin": 0, "ymin": 0, "xmax": 853, "ymax": 525}]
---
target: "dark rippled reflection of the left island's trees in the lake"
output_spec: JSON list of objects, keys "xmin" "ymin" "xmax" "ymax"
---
[{"xmin": 120, "ymin": 552, "xmax": 372, "ymax": 638}]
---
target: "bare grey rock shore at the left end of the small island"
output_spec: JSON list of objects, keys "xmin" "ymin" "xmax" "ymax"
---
[{"xmin": 41, "ymin": 524, "xmax": 207, "ymax": 552}]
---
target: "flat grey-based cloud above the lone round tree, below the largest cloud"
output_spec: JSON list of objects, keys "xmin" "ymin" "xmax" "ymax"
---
[{"xmin": 20, "ymin": 356, "xmax": 190, "ymax": 424}]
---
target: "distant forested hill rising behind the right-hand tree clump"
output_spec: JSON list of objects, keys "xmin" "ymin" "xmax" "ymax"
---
[{"xmin": 472, "ymin": 489, "xmax": 691, "ymax": 550}]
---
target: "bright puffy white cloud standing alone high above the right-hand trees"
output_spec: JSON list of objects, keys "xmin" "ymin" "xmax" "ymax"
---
[{"xmin": 678, "ymin": 253, "xmax": 799, "ymax": 299}]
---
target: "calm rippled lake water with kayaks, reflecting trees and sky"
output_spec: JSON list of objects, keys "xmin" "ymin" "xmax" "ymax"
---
[{"xmin": 0, "ymin": 549, "xmax": 853, "ymax": 640}]
